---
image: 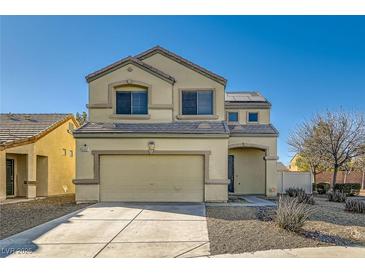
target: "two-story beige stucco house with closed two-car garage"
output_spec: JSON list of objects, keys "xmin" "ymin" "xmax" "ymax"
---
[{"xmin": 74, "ymin": 46, "xmax": 278, "ymax": 202}]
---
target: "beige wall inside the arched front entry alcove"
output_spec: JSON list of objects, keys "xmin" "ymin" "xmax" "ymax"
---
[{"xmin": 228, "ymin": 148, "xmax": 266, "ymax": 194}]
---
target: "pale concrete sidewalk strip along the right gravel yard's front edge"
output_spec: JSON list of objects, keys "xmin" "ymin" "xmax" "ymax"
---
[{"xmin": 208, "ymin": 246, "xmax": 365, "ymax": 258}]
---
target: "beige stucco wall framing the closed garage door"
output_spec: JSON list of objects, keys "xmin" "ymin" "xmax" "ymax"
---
[{"xmin": 76, "ymin": 137, "xmax": 228, "ymax": 201}]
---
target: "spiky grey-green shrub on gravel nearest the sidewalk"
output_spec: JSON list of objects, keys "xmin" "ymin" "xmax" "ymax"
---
[{"xmin": 275, "ymin": 196, "xmax": 313, "ymax": 231}]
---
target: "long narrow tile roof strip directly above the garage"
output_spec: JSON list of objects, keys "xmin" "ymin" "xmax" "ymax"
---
[{"xmin": 74, "ymin": 121, "xmax": 229, "ymax": 136}]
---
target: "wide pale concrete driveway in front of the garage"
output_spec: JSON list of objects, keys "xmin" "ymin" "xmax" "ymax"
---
[{"xmin": 0, "ymin": 203, "xmax": 209, "ymax": 258}]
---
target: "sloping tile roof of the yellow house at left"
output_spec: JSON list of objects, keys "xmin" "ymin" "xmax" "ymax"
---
[{"xmin": 0, "ymin": 113, "xmax": 72, "ymax": 145}]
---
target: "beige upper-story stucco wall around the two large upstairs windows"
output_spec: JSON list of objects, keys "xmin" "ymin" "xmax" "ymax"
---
[{"xmin": 89, "ymin": 54, "xmax": 225, "ymax": 123}]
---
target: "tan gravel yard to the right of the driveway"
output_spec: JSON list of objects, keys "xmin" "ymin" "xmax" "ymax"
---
[{"xmin": 207, "ymin": 197, "xmax": 365, "ymax": 255}]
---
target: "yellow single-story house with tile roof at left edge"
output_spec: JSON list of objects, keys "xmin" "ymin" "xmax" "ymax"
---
[{"xmin": 0, "ymin": 113, "xmax": 78, "ymax": 200}]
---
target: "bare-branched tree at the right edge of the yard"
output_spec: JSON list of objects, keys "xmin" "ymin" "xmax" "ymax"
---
[{"xmin": 288, "ymin": 112, "xmax": 365, "ymax": 187}]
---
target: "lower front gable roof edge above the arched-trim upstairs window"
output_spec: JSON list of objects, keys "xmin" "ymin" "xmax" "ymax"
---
[{"xmin": 85, "ymin": 56, "xmax": 175, "ymax": 83}]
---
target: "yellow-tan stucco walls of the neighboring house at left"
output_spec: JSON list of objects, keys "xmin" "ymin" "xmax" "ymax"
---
[{"xmin": 0, "ymin": 119, "xmax": 76, "ymax": 197}]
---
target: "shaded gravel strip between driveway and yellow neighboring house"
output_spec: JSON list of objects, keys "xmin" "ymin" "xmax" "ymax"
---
[{"xmin": 0, "ymin": 195, "xmax": 90, "ymax": 239}]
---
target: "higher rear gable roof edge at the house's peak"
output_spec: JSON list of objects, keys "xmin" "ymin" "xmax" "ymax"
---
[{"xmin": 134, "ymin": 46, "xmax": 227, "ymax": 86}]
